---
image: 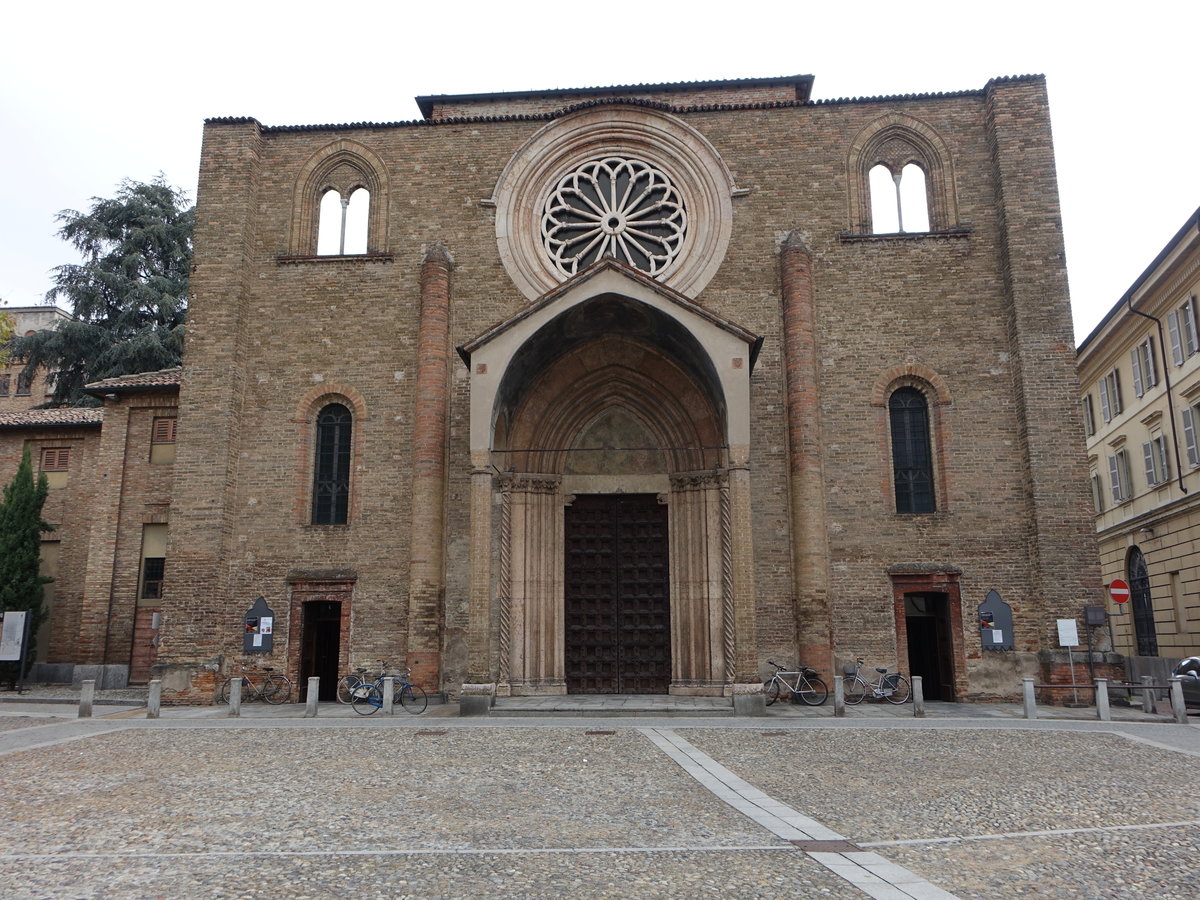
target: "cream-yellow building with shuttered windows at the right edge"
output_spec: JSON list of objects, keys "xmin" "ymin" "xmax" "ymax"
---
[{"xmin": 1076, "ymin": 210, "xmax": 1200, "ymax": 676}]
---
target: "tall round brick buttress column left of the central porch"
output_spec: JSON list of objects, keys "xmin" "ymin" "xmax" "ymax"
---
[{"xmin": 407, "ymin": 245, "xmax": 451, "ymax": 690}]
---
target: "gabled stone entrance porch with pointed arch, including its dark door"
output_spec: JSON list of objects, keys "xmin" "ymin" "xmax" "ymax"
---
[{"xmin": 462, "ymin": 260, "xmax": 757, "ymax": 694}]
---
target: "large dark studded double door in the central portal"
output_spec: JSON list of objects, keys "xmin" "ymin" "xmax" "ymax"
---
[{"xmin": 564, "ymin": 494, "xmax": 671, "ymax": 694}]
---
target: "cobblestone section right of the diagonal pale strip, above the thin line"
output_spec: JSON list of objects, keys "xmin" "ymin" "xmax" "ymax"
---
[{"xmin": 680, "ymin": 728, "xmax": 1200, "ymax": 844}]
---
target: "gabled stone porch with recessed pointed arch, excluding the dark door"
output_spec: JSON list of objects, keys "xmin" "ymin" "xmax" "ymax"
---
[{"xmin": 460, "ymin": 260, "xmax": 761, "ymax": 695}]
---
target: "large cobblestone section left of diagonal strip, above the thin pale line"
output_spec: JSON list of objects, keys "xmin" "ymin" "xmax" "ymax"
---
[{"xmin": 0, "ymin": 728, "xmax": 768, "ymax": 854}]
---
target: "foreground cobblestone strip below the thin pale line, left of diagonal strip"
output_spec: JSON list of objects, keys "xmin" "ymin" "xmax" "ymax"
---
[{"xmin": 0, "ymin": 848, "xmax": 849, "ymax": 900}]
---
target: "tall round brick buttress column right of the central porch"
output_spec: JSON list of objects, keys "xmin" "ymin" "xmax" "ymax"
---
[{"xmin": 779, "ymin": 233, "xmax": 833, "ymax": 672}]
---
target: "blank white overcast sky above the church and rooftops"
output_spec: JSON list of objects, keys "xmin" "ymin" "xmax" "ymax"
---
[{"xmin": 0, "ymin": 0, "xmax": 1200, "ymax": 338}]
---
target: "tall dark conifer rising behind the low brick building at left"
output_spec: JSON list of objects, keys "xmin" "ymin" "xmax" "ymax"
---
[{"xmin": 11, "ymin": 175, "xmax": 196, "ymax": 406}]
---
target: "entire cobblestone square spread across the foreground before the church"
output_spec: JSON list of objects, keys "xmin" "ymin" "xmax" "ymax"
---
[{"xmin": 0, "ymin": 704, "xmax": 1200, "ymax": 900}]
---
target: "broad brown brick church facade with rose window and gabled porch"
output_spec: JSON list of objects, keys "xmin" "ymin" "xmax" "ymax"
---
[{"xmin": 0, "ymin": 77, "xmax": 1099, "ymax": 701}]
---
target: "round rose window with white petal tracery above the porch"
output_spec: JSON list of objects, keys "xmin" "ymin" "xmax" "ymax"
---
[{"xmin": 541, "ymin": 156, "xmax": 688, "ymax": 276}]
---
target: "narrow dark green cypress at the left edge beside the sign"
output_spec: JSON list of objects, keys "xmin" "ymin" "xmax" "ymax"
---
[{"xmin": 0, "ymin": 448, "xmax": 53, "ymax": 682}]
